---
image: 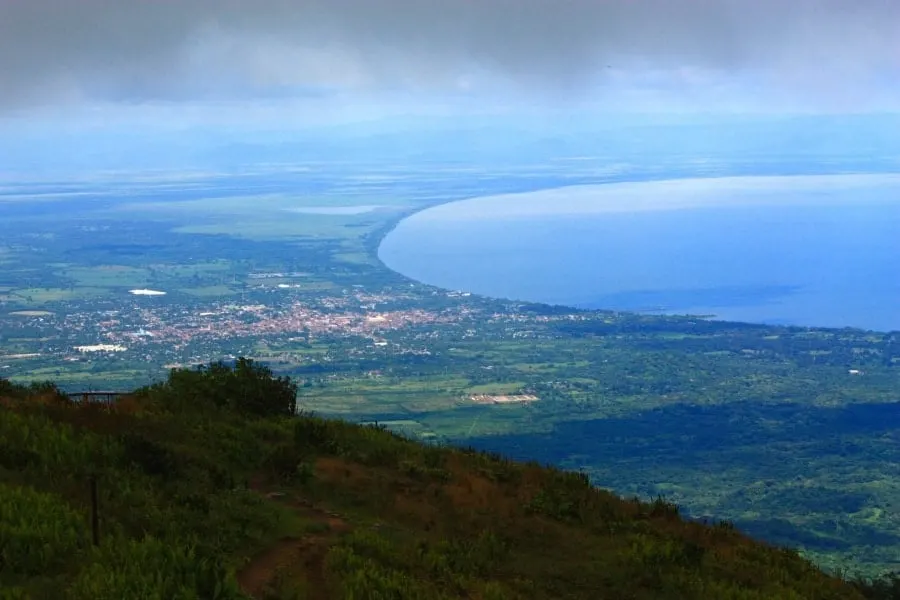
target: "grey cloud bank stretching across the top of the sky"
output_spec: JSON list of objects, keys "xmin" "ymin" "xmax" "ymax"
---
[{"xmin": 0, "ymin": 0, "xmax": 900, "ymax": 108}]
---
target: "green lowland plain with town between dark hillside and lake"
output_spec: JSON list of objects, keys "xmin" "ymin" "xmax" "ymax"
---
[{"xmin": 0, "ymin": 168, "xmax": 900, "ymax": 576}]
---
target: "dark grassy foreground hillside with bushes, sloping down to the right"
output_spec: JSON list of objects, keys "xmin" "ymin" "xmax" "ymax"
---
[{"xmin": 0, "ymin": 360, "xmax": 896, "ymax": 600}]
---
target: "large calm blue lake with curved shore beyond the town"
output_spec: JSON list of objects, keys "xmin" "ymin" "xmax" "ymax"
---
[{"xmin": 379, "ymin": 175, "xmax": 900, "ymax": 331}]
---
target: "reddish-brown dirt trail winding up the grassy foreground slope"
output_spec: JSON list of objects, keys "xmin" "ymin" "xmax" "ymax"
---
[{"xmin": 237, "ymin": 483, "xmax": 350, "ymax": 600}]
